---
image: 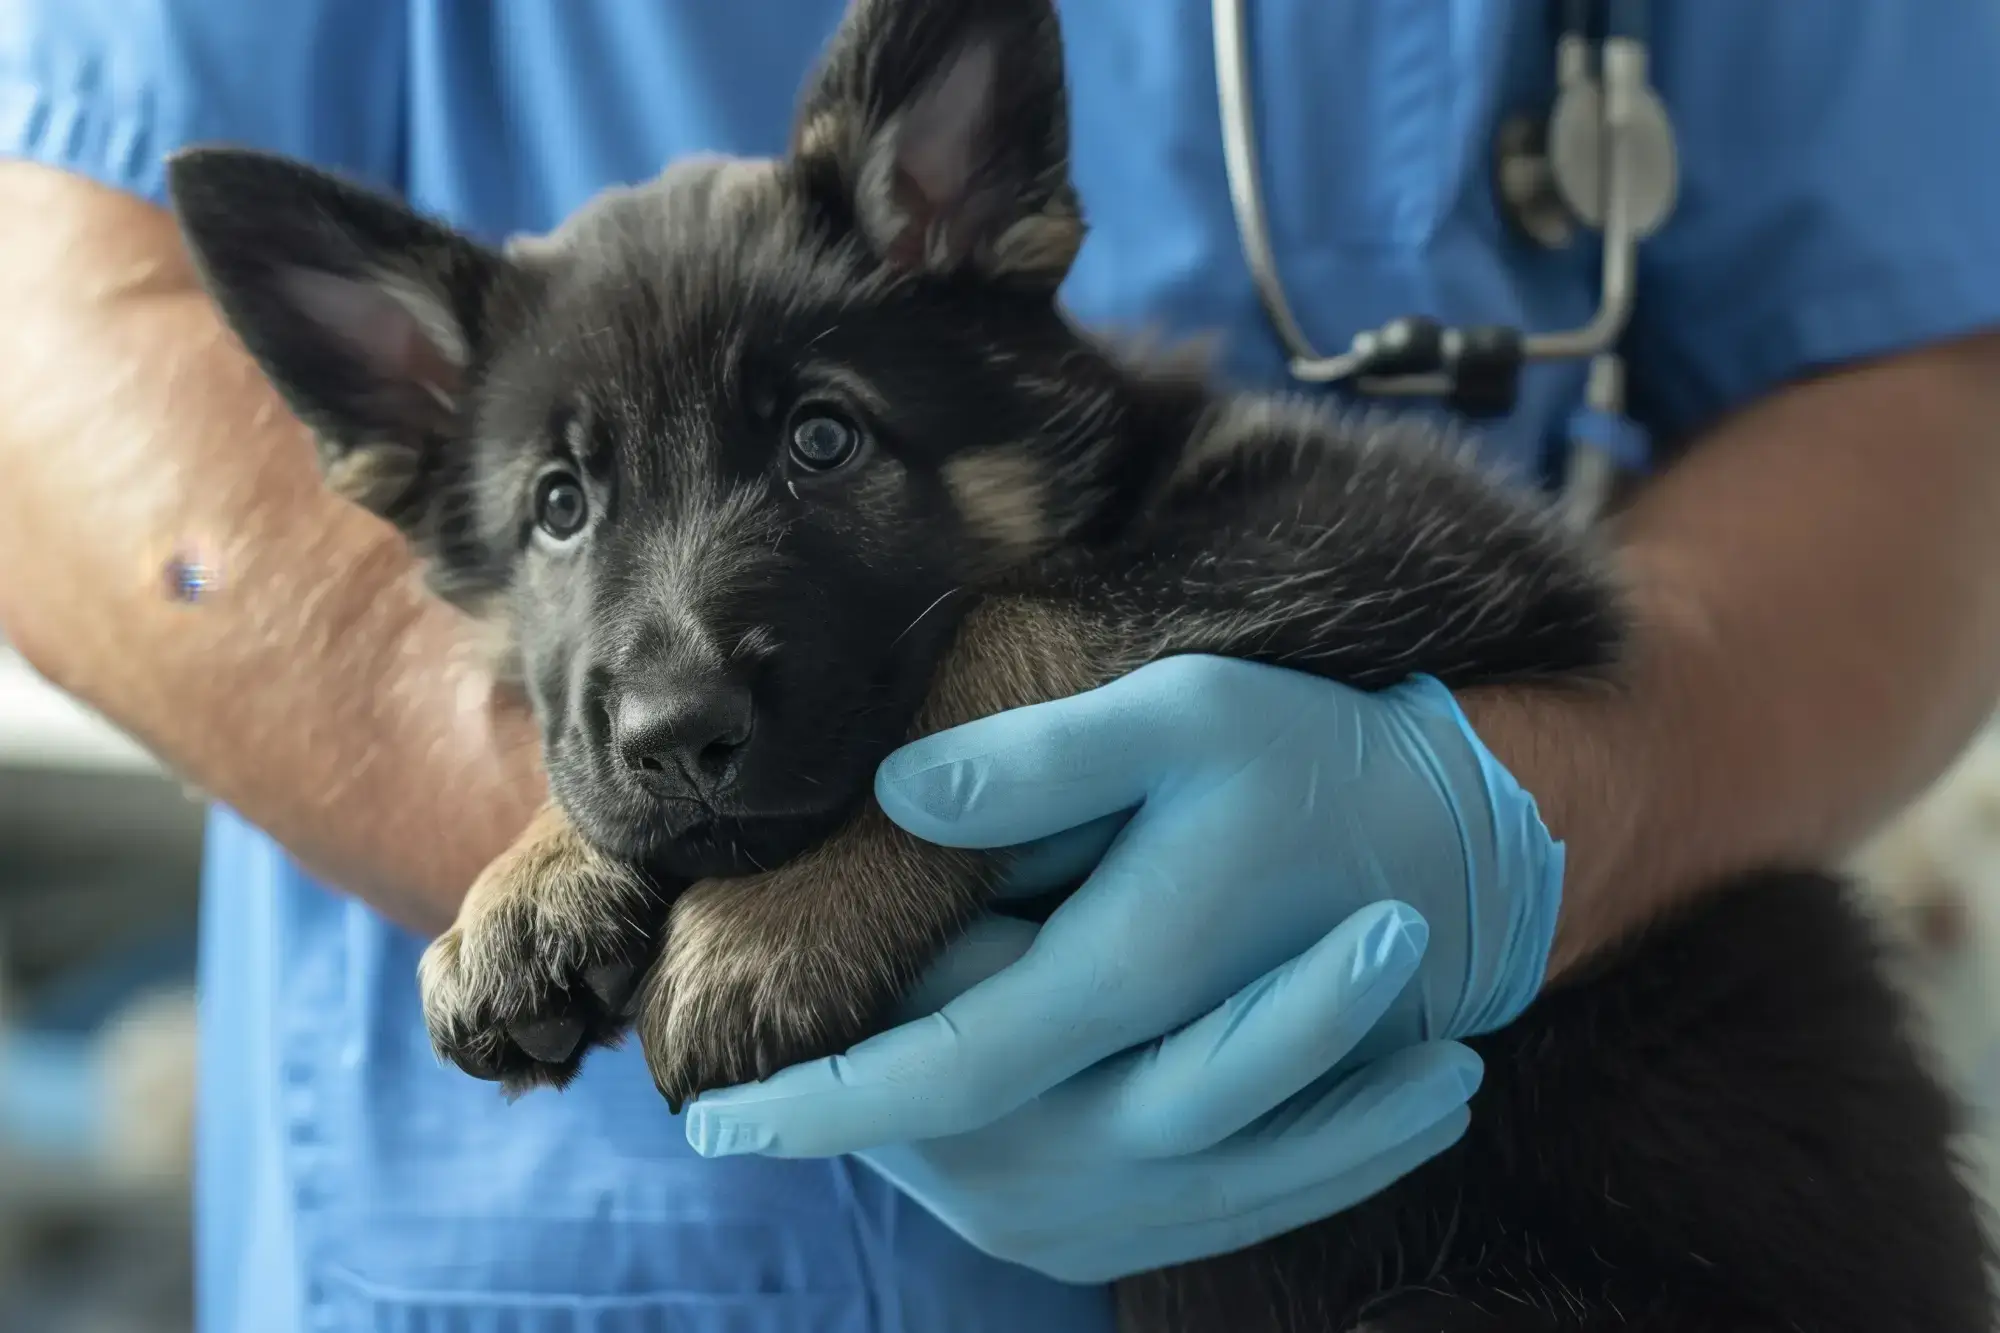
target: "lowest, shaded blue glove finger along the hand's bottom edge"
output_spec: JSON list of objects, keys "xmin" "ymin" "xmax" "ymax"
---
[{"xmin": 1014, "ymin": 1103, "xmax": 1472, "ymax": 1283}]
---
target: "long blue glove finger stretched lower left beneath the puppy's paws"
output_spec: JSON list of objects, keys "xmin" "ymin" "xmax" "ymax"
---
[{"xmin": 684, "ymin": 903, "xmax": 1420, "ymax": 1157}]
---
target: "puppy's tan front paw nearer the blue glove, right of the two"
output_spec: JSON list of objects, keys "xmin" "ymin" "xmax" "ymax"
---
[{"xmin": 634, "ymin": 869, "xmax": 922, "ymax": 1113}]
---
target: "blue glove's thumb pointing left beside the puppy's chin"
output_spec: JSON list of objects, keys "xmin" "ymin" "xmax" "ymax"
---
[{"xmin": 876, "ymin": 658, "xmax": 1238, "ymax": 847}]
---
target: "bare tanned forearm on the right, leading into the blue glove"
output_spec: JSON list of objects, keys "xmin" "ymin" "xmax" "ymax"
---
[{"xmin": 1466, "ymin": 336, "xmax": 2000, "ymax": 975}]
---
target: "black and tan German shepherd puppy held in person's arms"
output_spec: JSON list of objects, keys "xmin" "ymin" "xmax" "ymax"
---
[{"xmin": 170, "ymin": 0, "xmax": 1988, "ymax": 1333}]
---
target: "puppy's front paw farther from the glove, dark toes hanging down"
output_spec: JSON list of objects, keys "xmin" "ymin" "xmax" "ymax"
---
[{"xmin": 418, "ymin": 807, "xmax": 666, "ymax": 1095}]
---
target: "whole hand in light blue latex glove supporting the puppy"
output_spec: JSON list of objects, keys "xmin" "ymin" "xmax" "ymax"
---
[{"xmin": 686, "ymin": 656, "xmax": 1562, "ymax": 1281}]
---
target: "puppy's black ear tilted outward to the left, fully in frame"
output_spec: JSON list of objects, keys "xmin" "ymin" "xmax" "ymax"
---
[{"xmin": 166, "ymin": 148, "xmax": 508, "ymax": 536}]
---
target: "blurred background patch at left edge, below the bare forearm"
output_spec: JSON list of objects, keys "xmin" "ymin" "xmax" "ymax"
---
[{"xmin": 0, "ymin": 644, "xmax": 202, "ymax": 1333}]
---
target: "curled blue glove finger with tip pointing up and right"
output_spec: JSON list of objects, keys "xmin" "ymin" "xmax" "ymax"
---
[{"xmin": 1036, "ymin": 896, "xmax": 1430, "ymax": 1159}]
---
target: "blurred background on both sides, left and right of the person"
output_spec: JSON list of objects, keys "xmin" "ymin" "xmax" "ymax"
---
[{"xmin": 0, "ymin": 644, "xmax": 2000, "ymax": 1333}]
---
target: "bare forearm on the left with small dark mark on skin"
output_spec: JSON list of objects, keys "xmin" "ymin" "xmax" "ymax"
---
[{"xmin": 0, "ymin": 162, "xmax": 544, "ymax": 933}]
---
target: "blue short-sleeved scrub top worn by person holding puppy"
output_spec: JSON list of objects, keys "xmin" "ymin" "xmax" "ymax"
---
[{"xmin": 0, "ymin": 0, "xmax": 2000, "ymax": 1333}]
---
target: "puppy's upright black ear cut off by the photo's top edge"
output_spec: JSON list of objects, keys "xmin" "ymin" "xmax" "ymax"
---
[{"xmin": 792, "ymin": 0, "xmax": 1084, "ymax": 290}]
